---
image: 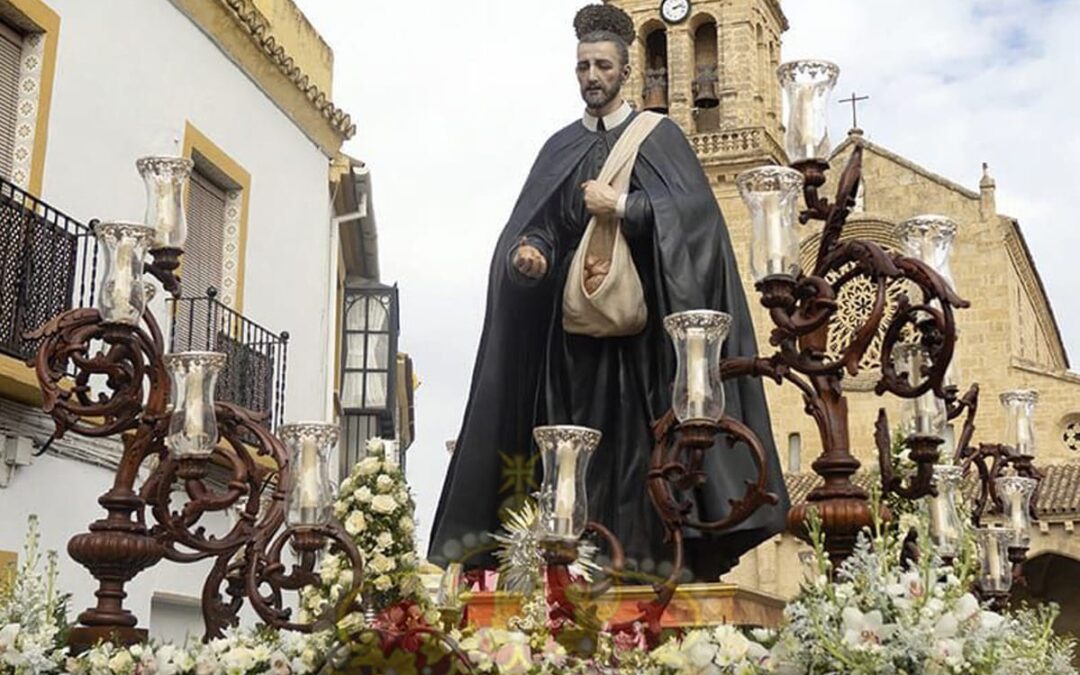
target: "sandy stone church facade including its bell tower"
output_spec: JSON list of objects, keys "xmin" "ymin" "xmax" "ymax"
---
[{"xmin": 611, "ymin": 0, "xmax": 1080, "ymax": 621}]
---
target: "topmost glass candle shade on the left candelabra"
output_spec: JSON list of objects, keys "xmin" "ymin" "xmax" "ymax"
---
[{"xmin": 135, "ymin": 157, "xmax": 194, "ymax": 249}]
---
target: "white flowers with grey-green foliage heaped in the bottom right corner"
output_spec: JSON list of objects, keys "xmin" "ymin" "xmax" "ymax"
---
[{"xmin": 756, "ymin": 505, "xmax": 1077, "ymax": 675}]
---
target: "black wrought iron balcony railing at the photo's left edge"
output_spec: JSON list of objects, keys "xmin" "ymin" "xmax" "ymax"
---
[{"xmin": 0, "ymin": 178, "xmax": 97, "ymax": 360}]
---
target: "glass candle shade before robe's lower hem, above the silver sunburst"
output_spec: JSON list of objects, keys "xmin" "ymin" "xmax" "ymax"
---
[{"xmin": 532, "ymin": 426, "xmax": 603, "ymax": 541}]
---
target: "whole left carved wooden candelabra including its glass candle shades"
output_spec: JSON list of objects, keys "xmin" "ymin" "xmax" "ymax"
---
[{"xmin": 29, "ymin": 158, "xmax": 362, "ymax": 651}]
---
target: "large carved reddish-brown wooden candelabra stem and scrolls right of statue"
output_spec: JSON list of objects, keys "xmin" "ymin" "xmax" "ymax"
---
[{"xmin": 757, "ymin": 145, "xmax": 968, "ymax": 565}]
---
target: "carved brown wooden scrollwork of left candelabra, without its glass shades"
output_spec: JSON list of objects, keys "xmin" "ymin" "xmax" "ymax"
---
[{"xmin": 32, "ymin": 309, "xmax": 362, "ymax": 650}]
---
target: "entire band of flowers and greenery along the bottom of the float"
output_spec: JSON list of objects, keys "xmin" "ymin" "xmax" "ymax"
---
[{"xmin": 6, "ymin": 443, "xmax": 1077, "ymax": 675}]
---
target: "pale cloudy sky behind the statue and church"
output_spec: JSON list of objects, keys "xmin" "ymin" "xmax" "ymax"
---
[{"xmin": 296, "ymin": 0, "xmax": 1080, "ymax": 542}]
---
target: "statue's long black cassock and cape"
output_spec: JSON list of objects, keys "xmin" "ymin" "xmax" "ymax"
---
[{"xmin": 429, "ymin": 113, "xmax": 788, "ymax": 581}]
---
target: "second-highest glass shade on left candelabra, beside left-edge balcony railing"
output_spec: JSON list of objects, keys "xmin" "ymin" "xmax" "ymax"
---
[{"xmin": 94, "ymin": 222, "xmax": 153, "ymax": 326}]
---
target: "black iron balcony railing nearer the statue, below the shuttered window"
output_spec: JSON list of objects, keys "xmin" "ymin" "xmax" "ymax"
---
[{"xmin": 168, "ymin": 287, "xmax": 288, "ymax": 430}]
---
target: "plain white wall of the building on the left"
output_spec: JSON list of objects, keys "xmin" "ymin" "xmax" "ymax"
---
[{"xmin": 0, "ymin": 0, "xmax": 333, "ymax": 626}]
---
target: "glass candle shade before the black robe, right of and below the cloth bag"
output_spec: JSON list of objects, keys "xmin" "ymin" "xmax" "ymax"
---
[{"xmin": 664, "ymin": 310, "xmax": 731, "ymax": 422}]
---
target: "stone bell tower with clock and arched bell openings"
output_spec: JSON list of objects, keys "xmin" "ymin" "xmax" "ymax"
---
[{"xmin": 607, "ymin": 0, "xmax": 787, "ymax": 173}]
